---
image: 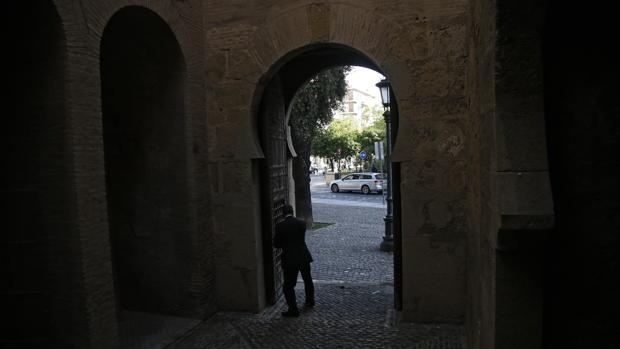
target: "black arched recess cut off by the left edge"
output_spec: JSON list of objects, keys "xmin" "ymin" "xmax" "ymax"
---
[{"xmin": 0, "ymin": 1, "xmax": 70, "ymax": 347}]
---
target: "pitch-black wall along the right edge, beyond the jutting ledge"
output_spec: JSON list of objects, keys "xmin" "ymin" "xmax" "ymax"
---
[{"xmin": 544, "ymin": 1, "xmax": 620, "ymax": 348}]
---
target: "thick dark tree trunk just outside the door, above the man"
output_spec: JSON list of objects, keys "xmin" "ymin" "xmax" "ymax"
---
[{"xmin": 293, "ymin": 144, "xmax": 314, "ymax": 229}]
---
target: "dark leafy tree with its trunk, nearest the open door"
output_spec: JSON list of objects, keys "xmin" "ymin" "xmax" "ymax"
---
[{"xmin": 289, "ymin": 67, "xmax": 350, "ymax": 227}]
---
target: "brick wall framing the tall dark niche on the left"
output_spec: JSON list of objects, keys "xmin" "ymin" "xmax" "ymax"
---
[{"xmin": 2, "ymin": 0, "xmax": 216, "ymax": 348}]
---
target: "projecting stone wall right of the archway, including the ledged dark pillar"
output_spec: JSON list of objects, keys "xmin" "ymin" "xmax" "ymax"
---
[{"xmin": 468, "ymin": 0, "xmax": 553, "ymax": 348}]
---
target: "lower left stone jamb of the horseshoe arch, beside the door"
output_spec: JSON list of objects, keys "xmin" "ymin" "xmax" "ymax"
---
[{"xmin": 210, "ymin": 160, "xmax": 265, "ymax": 312}]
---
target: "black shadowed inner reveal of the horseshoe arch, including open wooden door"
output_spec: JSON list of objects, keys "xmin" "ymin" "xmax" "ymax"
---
[{"xmin": 254, "ymin": 44, "xmax": 402, "ymax": 308}]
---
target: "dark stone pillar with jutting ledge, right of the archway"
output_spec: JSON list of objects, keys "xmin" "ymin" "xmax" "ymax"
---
[{"xmin": 495, "ymin": 0, "xmax": 553, "ymax": 349}]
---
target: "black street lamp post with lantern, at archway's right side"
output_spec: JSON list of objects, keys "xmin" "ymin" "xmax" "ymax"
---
[{"xmin": 376, "ymin": 79, "xmax": 394, "ymax": 251}]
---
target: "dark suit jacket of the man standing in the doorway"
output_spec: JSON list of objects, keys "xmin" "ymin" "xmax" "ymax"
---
[{"xmin": 273, "ymin": 216, "xmax": 312, "ymax": 268}]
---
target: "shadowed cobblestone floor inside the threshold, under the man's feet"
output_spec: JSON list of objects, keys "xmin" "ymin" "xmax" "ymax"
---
[{"xmin": 168, "ymin": 283, "xmax": 464, "ymax": 349}]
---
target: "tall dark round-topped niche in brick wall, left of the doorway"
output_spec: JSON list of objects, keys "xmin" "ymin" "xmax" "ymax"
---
[{"xmin": 101, "ymin": 6, "xmax": 191, "ymax": 314}]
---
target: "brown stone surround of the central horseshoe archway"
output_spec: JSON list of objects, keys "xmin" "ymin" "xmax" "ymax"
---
[{"xmin": 207, "ymin": 2, "xmax": 474, "ymax": 322}]
